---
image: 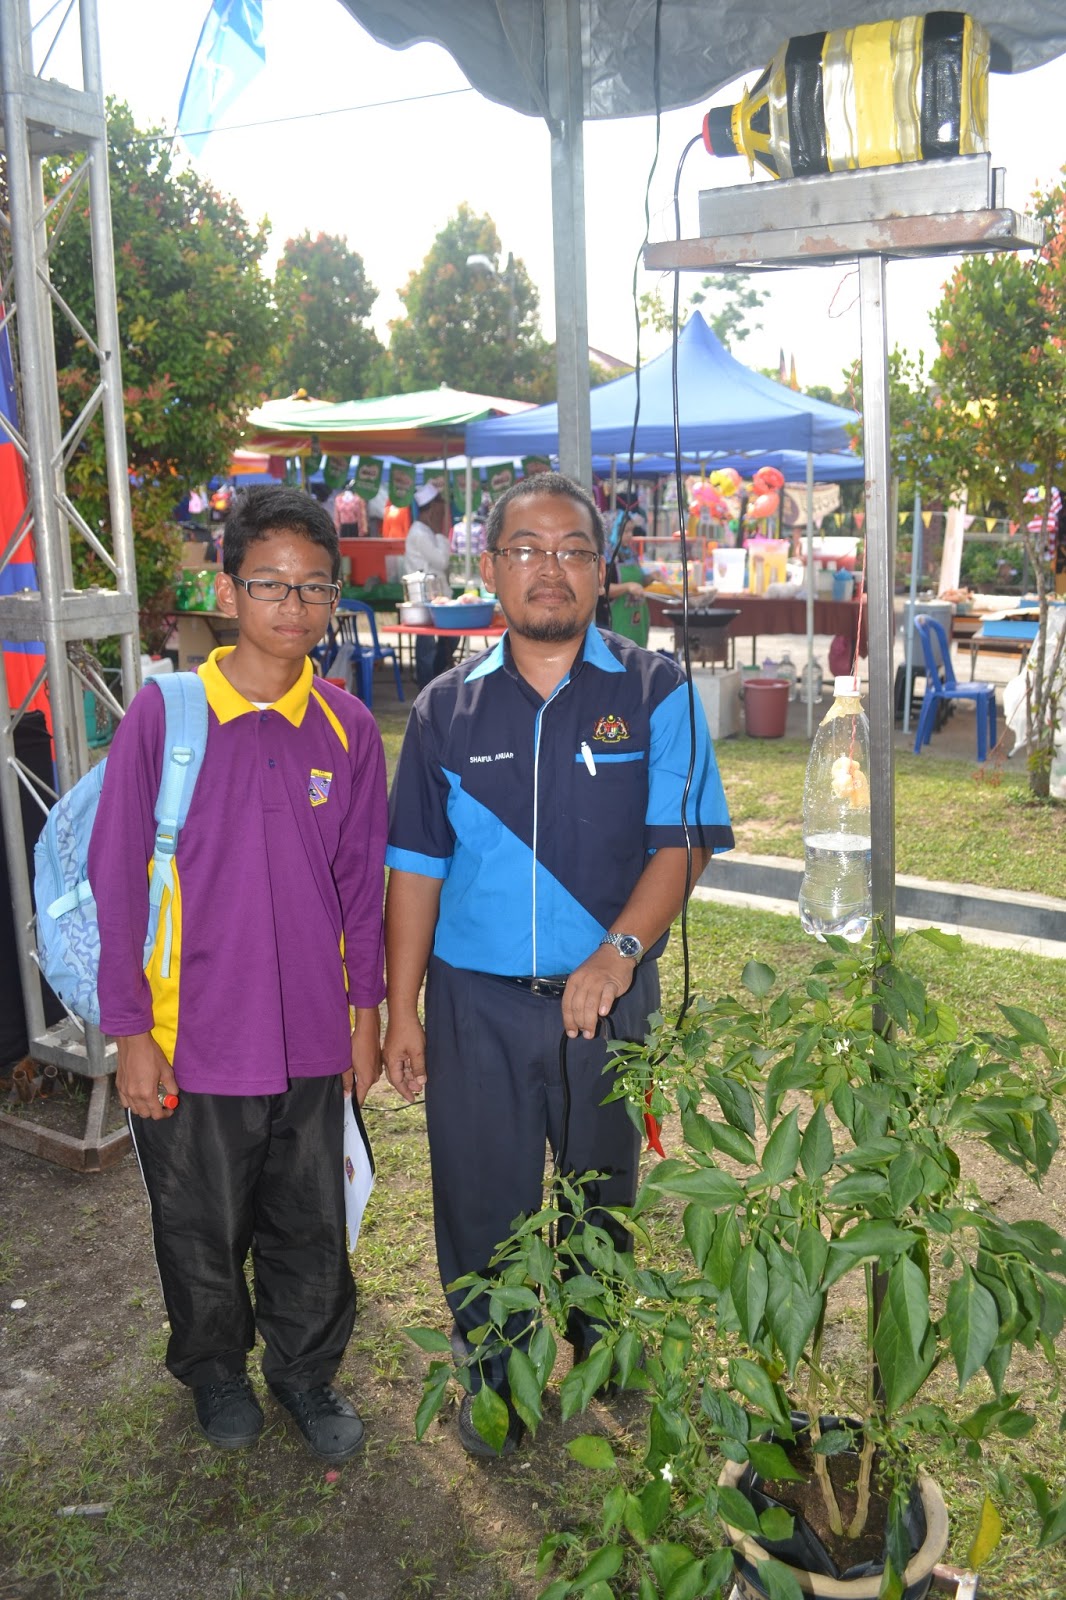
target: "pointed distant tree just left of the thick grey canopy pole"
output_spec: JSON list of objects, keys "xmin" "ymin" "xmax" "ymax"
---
[{"xmin": 382, "ymin": 205, "xmax": 555, "ymax": 400}]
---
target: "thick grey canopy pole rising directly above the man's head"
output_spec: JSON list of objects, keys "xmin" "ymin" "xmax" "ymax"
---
[{"xmin": 544, "ymin": 0, "xmax": 592, "ymax": 486}]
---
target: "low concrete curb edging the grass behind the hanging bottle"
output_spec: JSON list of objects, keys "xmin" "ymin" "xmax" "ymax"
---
[{"xmin": 695, "ymin": 851, "xmax": 1066, "ymax": 960}]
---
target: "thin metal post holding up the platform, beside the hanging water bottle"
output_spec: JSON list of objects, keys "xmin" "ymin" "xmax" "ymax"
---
[{"xmin": 858, "ymin": 256, "xmax": 896, "ymax": 939}]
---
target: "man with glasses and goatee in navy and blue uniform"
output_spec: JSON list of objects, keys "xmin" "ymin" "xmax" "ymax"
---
[{"xmin": 384, "ymin": 474, "xmax": 733, "ymax": 1454}]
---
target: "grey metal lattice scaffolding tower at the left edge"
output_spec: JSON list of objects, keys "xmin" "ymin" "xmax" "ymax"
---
[{"xmin": 0, "ymin": 0, "xmax": 141, "ymax": 1170}]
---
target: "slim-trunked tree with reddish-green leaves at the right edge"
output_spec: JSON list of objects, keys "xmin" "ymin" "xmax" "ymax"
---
[{"xmin": 933, "ymin": 173, "xmax": 1066, "ymax": 797}]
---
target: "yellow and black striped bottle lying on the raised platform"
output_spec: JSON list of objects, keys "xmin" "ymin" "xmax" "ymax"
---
[{"xmin": 703, "ymin": 11, "xmax": 989, "ymax": 178}]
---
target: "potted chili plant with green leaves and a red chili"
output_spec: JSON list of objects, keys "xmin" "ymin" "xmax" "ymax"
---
[{"xmin": 408, "ymin": 930, "xmax": 1066, "ymax": 1600}]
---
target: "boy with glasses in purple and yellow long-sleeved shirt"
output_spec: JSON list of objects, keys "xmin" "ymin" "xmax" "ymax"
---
[{"xmin": 90, "ymin": 486, "xmax": 386, "ymax": 1461}]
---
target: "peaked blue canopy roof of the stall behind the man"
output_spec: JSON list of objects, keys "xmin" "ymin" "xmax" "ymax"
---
[{"xmin": 466, "ymin": 310, "xmax": 856, "ymax": 456}]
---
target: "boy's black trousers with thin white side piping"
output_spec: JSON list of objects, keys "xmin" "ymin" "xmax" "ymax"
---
[{"xmin": 130, "ymin": 1074, "xmax": 355, "ymax": 1389}]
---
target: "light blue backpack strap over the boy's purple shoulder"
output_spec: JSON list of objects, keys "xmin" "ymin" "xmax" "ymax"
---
[{"xmin": 149, "ymin": 672, "xmax": 208, "ymax": 978}]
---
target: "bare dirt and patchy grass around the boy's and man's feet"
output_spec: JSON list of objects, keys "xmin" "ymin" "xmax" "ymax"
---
[{"xmin": 0, "ymin": 1088, "xmax": 639, "ymax": 1600}]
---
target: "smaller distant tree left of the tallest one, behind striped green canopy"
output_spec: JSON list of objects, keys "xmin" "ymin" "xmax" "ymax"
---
[{"xmin": 274, "ymin": 232, "xmax": 383, "ymax": 400}]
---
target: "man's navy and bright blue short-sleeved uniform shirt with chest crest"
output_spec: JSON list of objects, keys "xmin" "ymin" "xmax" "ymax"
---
[{"xmin": 386, "ymin": 627, "xmax": 733, "ymax": 976}]
